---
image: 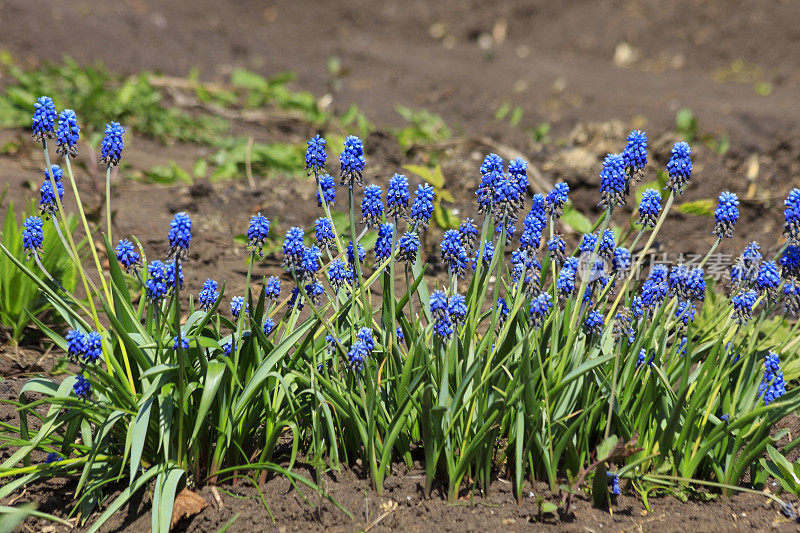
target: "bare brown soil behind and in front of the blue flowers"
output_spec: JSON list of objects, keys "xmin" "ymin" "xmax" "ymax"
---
[{"xmin": 0, "ymin": 0, "xmax": 800, "ymax": 531}]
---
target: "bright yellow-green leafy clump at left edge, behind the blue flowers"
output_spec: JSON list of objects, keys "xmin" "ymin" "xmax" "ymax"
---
[{"xmin": 0, "ymin": 200, "xmax": 82, "ymax": 343}]
